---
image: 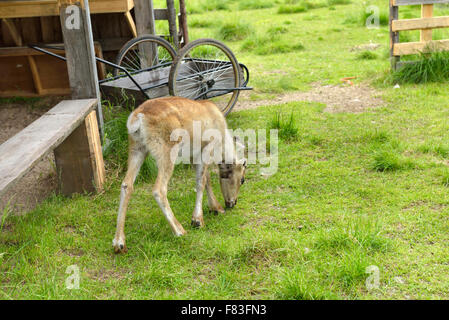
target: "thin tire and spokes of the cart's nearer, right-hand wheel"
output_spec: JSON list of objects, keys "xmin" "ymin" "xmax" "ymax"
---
[{"xmin": 168, "ymin": 39, "xmax": 243, "ymax": 116}]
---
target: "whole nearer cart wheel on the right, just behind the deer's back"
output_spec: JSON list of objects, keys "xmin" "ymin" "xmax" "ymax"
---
[{"xmin": 168, "ymin": 39, "xmax": 243, "ymax": 115}]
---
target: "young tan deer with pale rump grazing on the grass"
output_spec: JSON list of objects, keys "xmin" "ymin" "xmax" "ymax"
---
[{"xmin": 112, "ymin": 97, "xmax": 246, "ymax": 253}]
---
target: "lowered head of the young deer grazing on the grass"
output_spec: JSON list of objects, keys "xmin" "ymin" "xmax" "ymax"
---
[{"xmin": 218, "ymin": 138, "xmax": 246, "ymax": 208}]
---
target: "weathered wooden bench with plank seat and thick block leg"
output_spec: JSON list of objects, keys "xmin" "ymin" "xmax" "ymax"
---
[{"xmin": 0, "ymin": 99, "xmax": 105, "ymax": 196}]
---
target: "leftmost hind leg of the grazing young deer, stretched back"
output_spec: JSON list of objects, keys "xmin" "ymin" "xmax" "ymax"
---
[{"xmin": 112, "ymin": 146, "xmax": 146, "ymax": 253}]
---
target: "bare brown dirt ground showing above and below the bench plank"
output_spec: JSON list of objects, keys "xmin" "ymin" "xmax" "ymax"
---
[{"xmin": 0, "ymin": 97, "xmax": 63, "ymax": 215}]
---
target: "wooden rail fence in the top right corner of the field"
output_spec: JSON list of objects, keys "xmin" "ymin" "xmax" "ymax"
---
[{"xmin": 390, "ymin": 0, "xmax": 449, "ymax": 70}]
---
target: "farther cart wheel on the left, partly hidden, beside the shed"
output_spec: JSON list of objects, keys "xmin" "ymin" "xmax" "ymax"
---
[{"xmin": 113, "ymin": 34, "xmax": 176, "ymax": 77}]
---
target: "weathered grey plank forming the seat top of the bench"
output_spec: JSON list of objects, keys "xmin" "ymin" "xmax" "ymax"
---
[{"xmin": 0, "ymin": 99, "xmax": 97, "ymax": 195}]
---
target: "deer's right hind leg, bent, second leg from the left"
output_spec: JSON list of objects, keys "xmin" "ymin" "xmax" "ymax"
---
[{"xmin": 153, "ymin": 147, "xmax": 186, "ymax": 236}]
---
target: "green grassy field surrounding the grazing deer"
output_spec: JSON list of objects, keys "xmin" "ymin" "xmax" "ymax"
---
[{"xmin": 0, "ymin": 0, "xmax": 449, "ymax": 299}]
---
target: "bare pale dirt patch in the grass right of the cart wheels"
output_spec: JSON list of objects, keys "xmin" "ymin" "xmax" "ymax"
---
[{"xmin": 234, "ymin": 84, "xmax": 384, "ymax": 113}]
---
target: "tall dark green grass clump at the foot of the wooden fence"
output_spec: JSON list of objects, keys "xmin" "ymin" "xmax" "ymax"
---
[{"xmin": 391, "ymin": 49, "xmax": 449, "ymax": 84}]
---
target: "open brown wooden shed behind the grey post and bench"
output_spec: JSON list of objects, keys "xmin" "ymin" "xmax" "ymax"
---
[{"xmin": 0, "ymin": 0, "xmax": 137, "ymax": 97}]
